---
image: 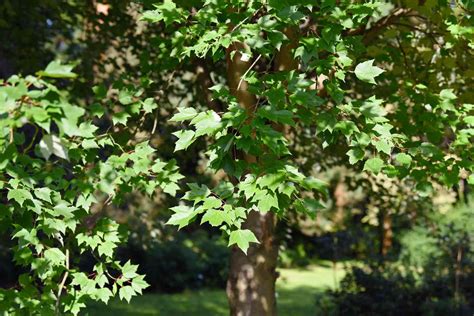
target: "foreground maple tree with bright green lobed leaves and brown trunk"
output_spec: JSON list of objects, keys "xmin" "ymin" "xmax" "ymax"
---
[{"xmin": 0, "ymin": 0, "xmax": 474, "ymax": 315}]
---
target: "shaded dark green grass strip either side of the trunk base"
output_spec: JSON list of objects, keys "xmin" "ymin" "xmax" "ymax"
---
[{"xmin": 81, "ymin": 286, "xmax": 330, "ymax": 316}]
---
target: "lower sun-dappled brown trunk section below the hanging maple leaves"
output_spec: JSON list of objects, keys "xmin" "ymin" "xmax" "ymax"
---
[{"xmin": 227, "ymin": 211, "xmax": 278, "ymax": 316}]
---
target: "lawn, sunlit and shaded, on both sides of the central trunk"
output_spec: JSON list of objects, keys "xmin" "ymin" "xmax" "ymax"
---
[{"xmin": 84, "ymin": 262, "xmax": 344, "ymax": 316}]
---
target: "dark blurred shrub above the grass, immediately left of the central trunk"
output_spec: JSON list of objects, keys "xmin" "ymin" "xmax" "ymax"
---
[{"xmin": 121, "ymin": 231, "xmax": 229, "ymax": 293}]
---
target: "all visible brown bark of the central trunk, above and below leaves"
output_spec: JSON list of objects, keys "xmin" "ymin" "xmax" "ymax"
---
[{"xmin": 227, "ymin": 43, "xmax": 278, "ymax": 316}]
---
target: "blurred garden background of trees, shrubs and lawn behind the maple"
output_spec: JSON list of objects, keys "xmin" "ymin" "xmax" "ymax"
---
[{"xmin": 0, "ymin": 0, "xmax": 474, "ymax": 316}]
